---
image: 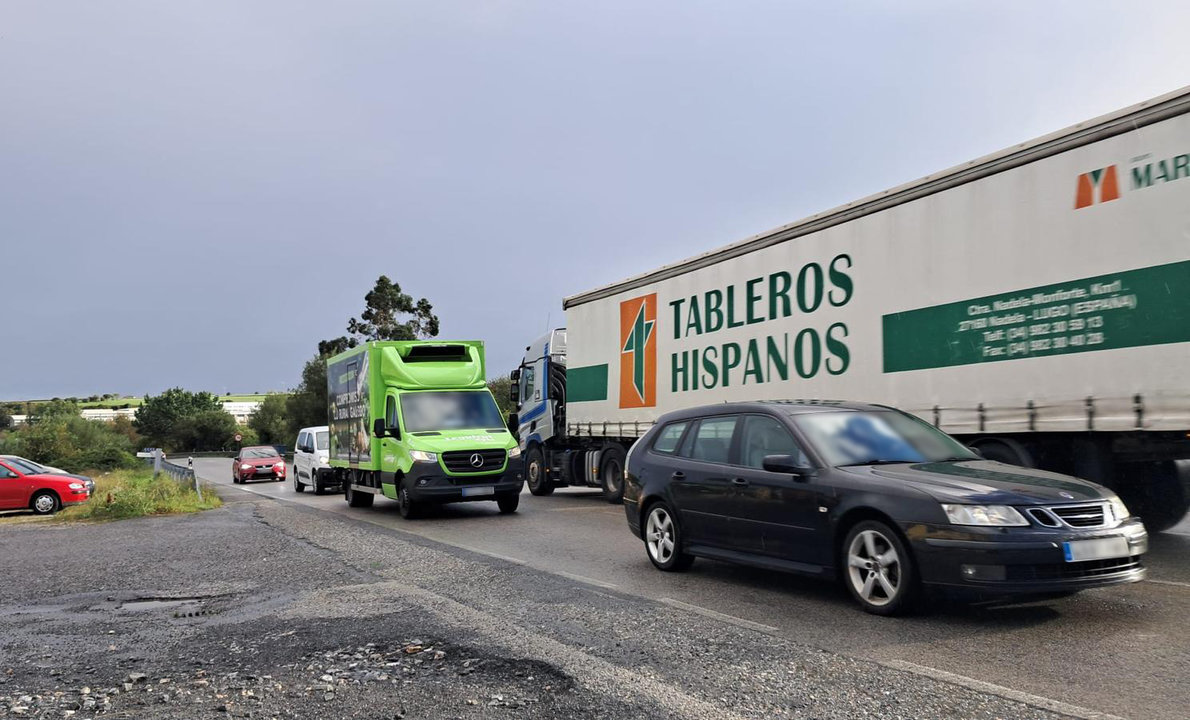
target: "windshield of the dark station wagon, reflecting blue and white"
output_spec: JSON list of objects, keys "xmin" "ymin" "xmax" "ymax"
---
[{"xmin": 793, "ymin": 411, "xmax": 978, "ymax": 468}]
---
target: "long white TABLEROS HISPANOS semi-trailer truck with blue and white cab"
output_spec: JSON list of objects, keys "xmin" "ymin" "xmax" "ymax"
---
[{"xmin": 513, "ymin": 88, "xmax": 1190, "ymax": 530}]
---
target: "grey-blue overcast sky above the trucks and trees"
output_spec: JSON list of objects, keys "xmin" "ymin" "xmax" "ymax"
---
[{"xmin": 0, "ymin": 0, "xmax": 1190, "ymax": 400}]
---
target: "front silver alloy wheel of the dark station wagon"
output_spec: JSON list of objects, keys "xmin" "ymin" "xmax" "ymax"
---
[{"xmin": 841, "ymin": 520, "xmax": 917, "ymax": 615}]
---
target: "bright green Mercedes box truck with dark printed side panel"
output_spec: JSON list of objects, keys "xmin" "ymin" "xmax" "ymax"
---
[{"xmin": 326, "ymin": 340, "xmax": 522, "ymax": 518}]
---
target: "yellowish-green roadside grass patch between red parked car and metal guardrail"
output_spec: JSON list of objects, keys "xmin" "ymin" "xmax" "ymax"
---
[{"xmin": 57, "ymin": 468, "xmax": 223, "ymax": 522}]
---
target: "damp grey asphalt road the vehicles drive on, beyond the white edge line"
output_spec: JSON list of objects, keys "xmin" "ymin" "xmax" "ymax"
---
[{"xmin": 195, "ymin": 458, "xmax": 1190, "ymax": 718}]
